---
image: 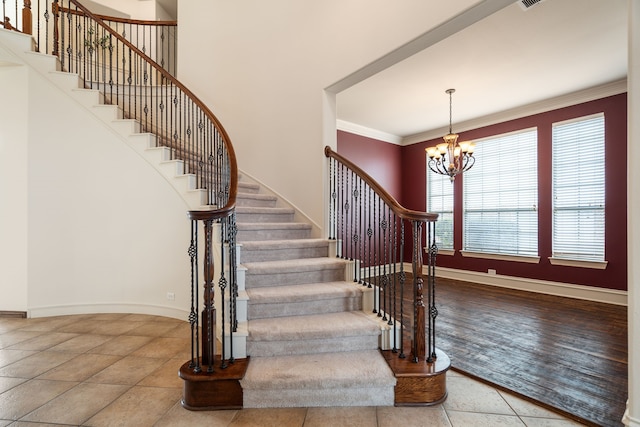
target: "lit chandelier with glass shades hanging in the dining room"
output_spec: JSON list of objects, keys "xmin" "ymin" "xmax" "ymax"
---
[{"xmin": 425, "ymin": 89, "xmax": 476, "ymax": 182}]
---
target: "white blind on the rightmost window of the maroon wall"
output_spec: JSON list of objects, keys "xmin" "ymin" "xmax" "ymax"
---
[{"xmin": 552, "ymin": 114, "xmax": 605, "ymax": 261}]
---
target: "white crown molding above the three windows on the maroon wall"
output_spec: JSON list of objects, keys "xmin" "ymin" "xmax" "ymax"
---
[{"xmin": 400, "ymin": 78, "xmax": 627, "ymax": 145}]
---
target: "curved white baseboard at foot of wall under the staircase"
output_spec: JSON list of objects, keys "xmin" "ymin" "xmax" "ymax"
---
[{"xmin": 27, "ymin": 304, "xmax": 189, "ymax": 321}]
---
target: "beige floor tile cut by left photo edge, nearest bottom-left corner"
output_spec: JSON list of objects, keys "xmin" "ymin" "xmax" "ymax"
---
[{"xmin": 0, "ymin": 380, "xmax": 77, "ymax": 420}]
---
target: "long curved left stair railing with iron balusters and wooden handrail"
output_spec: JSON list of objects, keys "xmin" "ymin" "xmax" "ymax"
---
[{"xmin": 47, "ymin": 0, "xmax": 238, "ymax": 373}]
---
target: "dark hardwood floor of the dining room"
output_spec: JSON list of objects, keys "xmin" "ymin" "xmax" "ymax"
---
[{"xmin": 428, "ymin": 279, "xmax": 627, "ymax": 426}]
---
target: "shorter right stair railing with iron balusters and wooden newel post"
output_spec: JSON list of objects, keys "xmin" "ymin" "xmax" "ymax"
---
[{"xmin": 325, "ymin": 147, "xmax": 438, "ymax": 363}]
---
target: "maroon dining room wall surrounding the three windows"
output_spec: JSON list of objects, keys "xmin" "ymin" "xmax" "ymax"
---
[{"xmin": 338, "ymin": 94, "xmax": 627, "ymax": 290}]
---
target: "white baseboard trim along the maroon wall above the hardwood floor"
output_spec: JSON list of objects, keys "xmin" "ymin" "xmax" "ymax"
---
[{"xmin": 428, "ymin": 264, "xmax": 627, "ymax": 306}]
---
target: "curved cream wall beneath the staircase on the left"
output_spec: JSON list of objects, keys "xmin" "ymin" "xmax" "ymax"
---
[{"xmin": 0, "ymin": 31, "xmax": 190, "ymax": 319}]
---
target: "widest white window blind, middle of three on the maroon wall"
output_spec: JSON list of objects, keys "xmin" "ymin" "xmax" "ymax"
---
[{"xmin": 463, "ymin": 128, "xmax": 538, "ymax": 256}]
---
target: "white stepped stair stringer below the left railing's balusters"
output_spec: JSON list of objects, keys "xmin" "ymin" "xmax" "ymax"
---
[{"xmin": 9, "ymin": 34, "xmax": 206, "ymax": 210}]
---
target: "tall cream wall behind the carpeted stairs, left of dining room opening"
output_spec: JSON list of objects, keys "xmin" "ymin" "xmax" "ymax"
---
[{"xmin": 178, "ymin": 0, "xmax": 474, "ymax": 224}]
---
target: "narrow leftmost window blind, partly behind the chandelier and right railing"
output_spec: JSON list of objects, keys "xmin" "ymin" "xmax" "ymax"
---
[{"xmin": 427, "ymin": 163, "xmax": 453, "ymax": 249}]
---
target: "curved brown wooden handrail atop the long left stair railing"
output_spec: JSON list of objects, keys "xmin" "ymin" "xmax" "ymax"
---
[{"xmin": 58, "ymin": 0, "xmax": 238, "ymax": 214}]
